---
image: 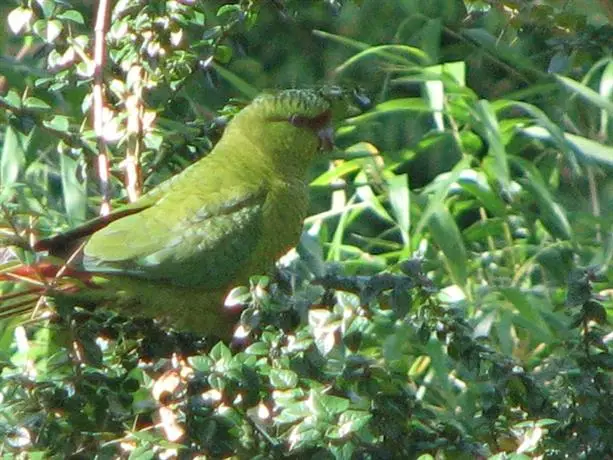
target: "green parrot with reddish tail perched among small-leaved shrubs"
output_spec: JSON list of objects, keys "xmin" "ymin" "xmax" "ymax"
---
[{"xmin": 0, "ymin": 88, "xmax": 356, "ymax": 338}]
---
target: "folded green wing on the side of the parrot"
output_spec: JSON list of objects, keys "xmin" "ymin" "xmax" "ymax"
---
[{"xmin": 83, "ymin": 185, "xmax": 267, "ymax": 289}]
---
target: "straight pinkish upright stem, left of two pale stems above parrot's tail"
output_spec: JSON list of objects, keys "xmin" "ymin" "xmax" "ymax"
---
[{"xmin": 92, "ymin": 0, "xmax": 111, "ymax": 216}]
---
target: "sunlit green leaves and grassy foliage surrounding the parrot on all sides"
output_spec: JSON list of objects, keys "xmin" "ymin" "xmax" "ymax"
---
[{"xmin": 0, "ymin": 0, "xmax": 613, "ymax": 459}]
